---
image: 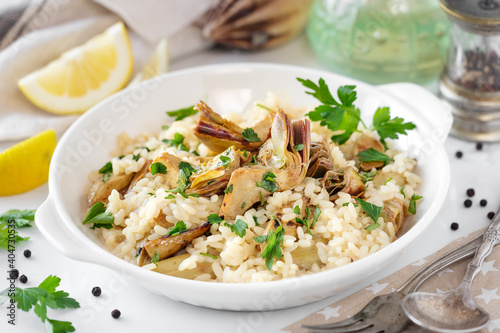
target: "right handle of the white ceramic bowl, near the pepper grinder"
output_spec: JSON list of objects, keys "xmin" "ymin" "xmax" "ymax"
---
[{"xmin": 378, "ymin": 82, "xmax": 453, "ymax": 141}]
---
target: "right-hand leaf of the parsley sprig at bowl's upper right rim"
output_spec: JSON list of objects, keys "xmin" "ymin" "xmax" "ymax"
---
[{"xmin": 372, "ymin": 107, "xmax": 417, "ymax": 145}]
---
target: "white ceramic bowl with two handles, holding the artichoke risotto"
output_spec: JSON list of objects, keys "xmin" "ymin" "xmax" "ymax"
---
[{"xmin": 36, "ymin": 63, "xmax": 451, "ymax": 310}]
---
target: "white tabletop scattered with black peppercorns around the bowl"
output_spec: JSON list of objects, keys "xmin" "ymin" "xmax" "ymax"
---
[{"xmin": 0, "ymin": 36, "xmax": 500, "ymax": 333}]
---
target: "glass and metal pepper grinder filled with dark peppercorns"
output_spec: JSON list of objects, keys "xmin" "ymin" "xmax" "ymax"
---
[{"xmin": 439, "ymin": 0, "xmax": 500, "ymax": 141}]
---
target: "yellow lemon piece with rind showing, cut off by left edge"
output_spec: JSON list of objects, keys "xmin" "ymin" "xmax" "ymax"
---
[{"xmin": 0, "ymin": 130, "xmax": 57, "ymax": 196}]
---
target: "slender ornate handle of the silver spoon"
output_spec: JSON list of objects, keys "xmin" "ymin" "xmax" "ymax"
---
[{"xmin": 462, "ymin": 211, "xmax": 500, "ymax": 283}]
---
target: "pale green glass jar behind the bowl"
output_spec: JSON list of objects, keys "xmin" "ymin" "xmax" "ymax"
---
[{"xmin": 307, "ymin": 0, "xmax": 449, "ymax": 84}]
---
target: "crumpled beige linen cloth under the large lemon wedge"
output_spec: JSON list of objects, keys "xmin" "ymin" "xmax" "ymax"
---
[{"xmin": 0, "ymin": 0, "xmax": 217, "ymax": 142}]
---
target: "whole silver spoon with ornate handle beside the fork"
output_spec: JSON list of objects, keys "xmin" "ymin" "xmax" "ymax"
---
[{"xmin": 402, "ymin": 210, "xmax": 500, "ymax": 332}]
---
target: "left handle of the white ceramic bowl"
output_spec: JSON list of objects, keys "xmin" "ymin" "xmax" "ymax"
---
[{"xmin": 35, "ymin": 195, "xmax": 100, "ymax": 263}]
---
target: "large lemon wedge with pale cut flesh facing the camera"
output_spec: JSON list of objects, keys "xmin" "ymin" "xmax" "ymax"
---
[{"xmin": 18, "ymin": 22, "xmax": 133, "ymax": 114}]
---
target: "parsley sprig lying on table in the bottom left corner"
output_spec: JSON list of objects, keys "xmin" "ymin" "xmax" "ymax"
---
[{"xmin": 0, "ymin": 275, "xmax": 80, "ymax": 333}]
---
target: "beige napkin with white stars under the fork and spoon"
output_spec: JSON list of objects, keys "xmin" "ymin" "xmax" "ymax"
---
[{"xmin": 282, "ymin": 230, "xmax": 500, "ymax": 333}]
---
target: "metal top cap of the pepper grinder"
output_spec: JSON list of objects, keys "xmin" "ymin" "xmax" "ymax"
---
[{"xmin": 439, "ymin": 0, "xmax": 500, "ymax": 31}]
